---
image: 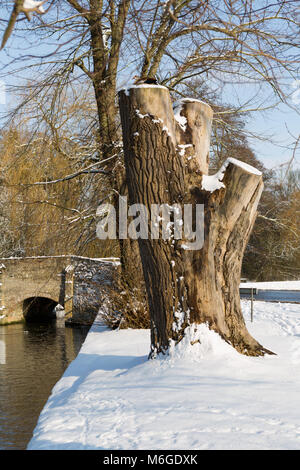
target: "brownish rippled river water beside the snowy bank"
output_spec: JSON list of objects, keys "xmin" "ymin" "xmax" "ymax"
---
[{"xmin": 0, "ymin": 320, "xmax": 88, "ymax": 450}]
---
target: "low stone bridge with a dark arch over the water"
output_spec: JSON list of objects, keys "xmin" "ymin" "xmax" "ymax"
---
[{"xmin": 0, "ymin": 255, "xmax": 119, "ymax": 325}]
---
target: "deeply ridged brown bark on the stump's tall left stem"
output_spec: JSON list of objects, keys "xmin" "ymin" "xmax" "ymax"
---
[{"xmin": 120, "ymin": 87, "xmax": 187, "ymax": 352}]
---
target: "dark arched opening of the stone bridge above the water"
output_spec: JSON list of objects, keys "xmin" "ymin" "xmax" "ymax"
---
[{"xmin": 23, "ymin": 296, "xmax": 58, "ymax": 323}]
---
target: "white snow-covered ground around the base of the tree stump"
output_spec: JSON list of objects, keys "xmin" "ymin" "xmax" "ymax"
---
[{"xmin": 28, "ymin": 301, "xmax": 300, "ymax": 450}]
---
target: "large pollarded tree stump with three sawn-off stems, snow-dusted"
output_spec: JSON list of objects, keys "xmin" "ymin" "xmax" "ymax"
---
[{"xmin": 119, "ymin": 85, "xmax": 271, "ymax": 357}]
